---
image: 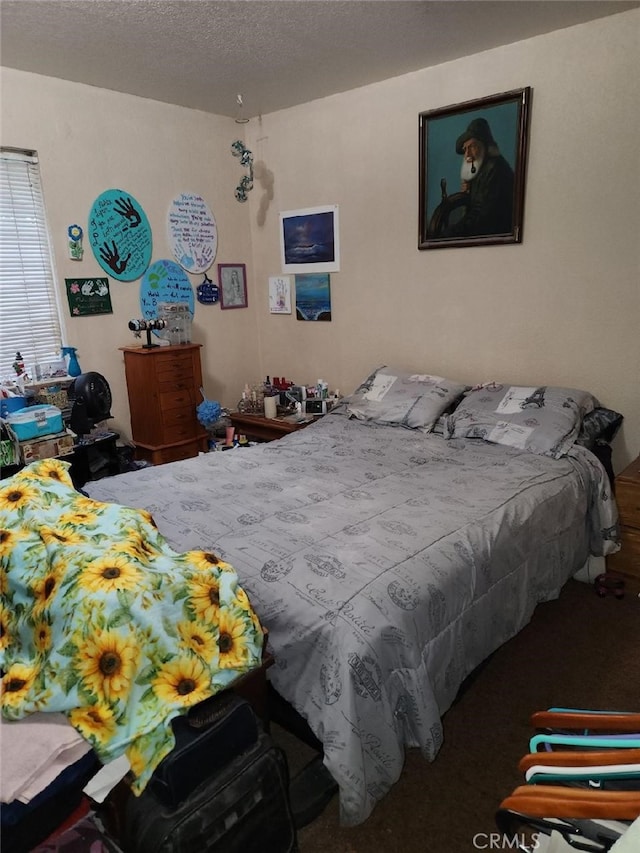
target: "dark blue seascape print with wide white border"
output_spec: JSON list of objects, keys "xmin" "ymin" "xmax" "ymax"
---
[{"xmin": 280, "ymin": 204, "xmax": 340, "ymax": 273}]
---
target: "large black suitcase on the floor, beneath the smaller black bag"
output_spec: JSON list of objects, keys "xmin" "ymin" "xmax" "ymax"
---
[{"xmin": 116, "ymin": 732, "xmax": 298, "ymax": 853}]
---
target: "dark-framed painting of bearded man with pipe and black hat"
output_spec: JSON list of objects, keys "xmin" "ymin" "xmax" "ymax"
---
[{"xmin": 418, "ymin": 87, "xmax": 531, "ymax": 249}]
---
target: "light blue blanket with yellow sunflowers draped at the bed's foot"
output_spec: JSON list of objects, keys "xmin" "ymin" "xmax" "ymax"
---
[{"xmin": 0, "ymin": 459, "xmax": 263, "ymax": 794}]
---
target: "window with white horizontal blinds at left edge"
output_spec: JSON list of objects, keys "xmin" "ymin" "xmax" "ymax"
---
[{"xmin": 0, "ymin": 148, "xmax": 62, "ymax": 379}]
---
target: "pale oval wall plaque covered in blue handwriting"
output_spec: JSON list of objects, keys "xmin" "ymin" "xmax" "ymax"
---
[{"xmin": 167, "ymin": 193, "xmax": 218, "ymax": 273}]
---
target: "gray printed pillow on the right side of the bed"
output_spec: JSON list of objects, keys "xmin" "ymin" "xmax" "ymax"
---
[{"xmin": 445, "ymin": 382, "xmax": 598, "ymax": 459}]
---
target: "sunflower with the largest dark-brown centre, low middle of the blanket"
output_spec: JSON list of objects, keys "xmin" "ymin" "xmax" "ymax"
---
[{"xmin": 73, "ymin": 630, "xmax": 140, "ymax": 703}]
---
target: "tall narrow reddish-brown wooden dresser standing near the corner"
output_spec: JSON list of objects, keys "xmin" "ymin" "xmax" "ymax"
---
[{"xmin": 121, "ymin": 344, "xmax": 207, "ymax": 465}]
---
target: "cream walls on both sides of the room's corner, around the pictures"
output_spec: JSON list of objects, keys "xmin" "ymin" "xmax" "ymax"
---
[{"xmin": 1, "ymin": 10, "xmax": 640, "ymax": 469}]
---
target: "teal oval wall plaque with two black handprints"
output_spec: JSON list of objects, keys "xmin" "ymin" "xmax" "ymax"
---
[{"xmin": 89, "ymin": 189, "xmax": 151, "ymax": 281}]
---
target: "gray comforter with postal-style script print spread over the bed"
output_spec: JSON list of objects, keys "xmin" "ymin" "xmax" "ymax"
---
[{"xmin": 86, "ymin": 412, "xmax": 618, "ymax": 825}]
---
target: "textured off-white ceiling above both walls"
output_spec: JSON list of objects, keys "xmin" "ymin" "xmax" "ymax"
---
[{"xmin": 0, "ymin": 0, "xmax": 640, "ymax": 118}]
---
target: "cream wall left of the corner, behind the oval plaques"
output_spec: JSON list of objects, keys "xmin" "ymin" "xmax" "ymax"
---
[{"xmin": 0, "ymin": 73, "xmax": 260, "ymax": 438}]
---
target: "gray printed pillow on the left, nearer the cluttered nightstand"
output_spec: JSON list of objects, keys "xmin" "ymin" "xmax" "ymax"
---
[{"xmin": 347, "ymin": 365, "xmax": 469, "ymax": 432}]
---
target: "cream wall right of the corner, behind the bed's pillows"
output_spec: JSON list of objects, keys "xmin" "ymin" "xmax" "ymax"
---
[{"xmin": 247, "ymin": 10, "xmax": 640, "ymax": 472}]
